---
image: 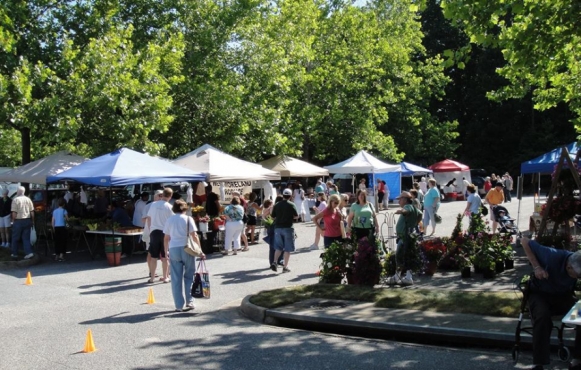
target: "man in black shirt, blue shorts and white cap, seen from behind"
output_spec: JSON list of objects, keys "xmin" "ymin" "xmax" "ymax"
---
[{"xmin": 270, "ymin": 189, "xmax": 299, "ymax": 272}]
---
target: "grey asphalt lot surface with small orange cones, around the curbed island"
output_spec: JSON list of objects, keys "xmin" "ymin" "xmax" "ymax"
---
[{"xmin": 0, "ymin": 198, "xmax": 566, "ymax": 369}]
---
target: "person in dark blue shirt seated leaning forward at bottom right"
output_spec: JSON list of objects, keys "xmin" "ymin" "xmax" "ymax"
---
[{"xmin": 521, "ymin": 237, "xmax": 581, "ymax": 370}]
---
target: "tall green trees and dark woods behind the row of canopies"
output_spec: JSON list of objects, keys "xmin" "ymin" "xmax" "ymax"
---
[{"xmin": 0, "ymin": 0, "xmax": 577, "ymax": 173}]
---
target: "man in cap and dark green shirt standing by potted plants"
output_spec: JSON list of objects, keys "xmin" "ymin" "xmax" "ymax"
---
[{"xmin": 388, "ymin": 191, "xmax": 422, "ymax": 286}]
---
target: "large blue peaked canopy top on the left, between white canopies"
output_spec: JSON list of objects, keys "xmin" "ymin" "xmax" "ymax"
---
[{"xmin": 46, "ymin": 148, "xmax": 206, "ymax": 186}]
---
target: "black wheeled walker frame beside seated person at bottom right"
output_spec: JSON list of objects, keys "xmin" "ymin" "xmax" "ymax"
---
[{"xmin": 512, "ymin": 274, "xmax": 571, "ymax": 363}]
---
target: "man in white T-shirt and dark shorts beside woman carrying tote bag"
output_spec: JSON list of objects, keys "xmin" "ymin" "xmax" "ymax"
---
[{"xmin": 147, "ymin": 188, "xmax": 173, "ymax": 283}]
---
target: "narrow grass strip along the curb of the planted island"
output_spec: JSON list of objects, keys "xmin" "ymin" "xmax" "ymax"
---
[{"xmin": 250, "ymin": 284, "xmax": 520, "ymax": 317}]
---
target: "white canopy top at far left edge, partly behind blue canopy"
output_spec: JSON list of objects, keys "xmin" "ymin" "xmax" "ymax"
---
[{"xmin": 0, "ymin": 151, "xmax": 88, "ymax": 185}]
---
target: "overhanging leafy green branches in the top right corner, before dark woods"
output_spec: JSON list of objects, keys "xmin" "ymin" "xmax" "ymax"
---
[{"xmin": 442, "ymin": 0, "xmax": 581, "ymax": 130}]
